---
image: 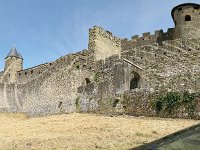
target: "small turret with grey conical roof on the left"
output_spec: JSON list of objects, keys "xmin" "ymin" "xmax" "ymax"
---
[{"xmin": 4, "ymin": 46, "xmax": 23, "ymax": 83}]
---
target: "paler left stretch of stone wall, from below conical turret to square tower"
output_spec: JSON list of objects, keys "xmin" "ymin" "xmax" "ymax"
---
[{"xmin": 0, "ymin": 50, "xmax": 96, "ymax": 116}]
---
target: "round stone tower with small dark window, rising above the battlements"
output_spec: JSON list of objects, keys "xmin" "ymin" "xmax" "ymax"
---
[{"xmin": 171, "ymin": 3, "xmax": 200, "ymax": 39}]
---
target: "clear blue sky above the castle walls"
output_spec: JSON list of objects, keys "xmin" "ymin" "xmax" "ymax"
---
[{"xmin": 0, "ymin": 0, "xmax": 200, "ymax": 70}]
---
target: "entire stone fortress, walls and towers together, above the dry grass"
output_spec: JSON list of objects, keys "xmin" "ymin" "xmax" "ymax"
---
[{"xmin": 0, "ymin": 3, "xmax": 200, "ymax": 118}]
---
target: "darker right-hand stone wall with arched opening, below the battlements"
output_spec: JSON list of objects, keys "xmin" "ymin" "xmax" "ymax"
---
[{"xmin": 78, "ymin": 36, "xmax": 200, "ymax": 118}]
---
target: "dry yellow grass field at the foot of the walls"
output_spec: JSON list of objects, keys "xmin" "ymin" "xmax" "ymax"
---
[{"xmin": 0, "ymin": 113, "xmax": 199, "ymax": 150}]
